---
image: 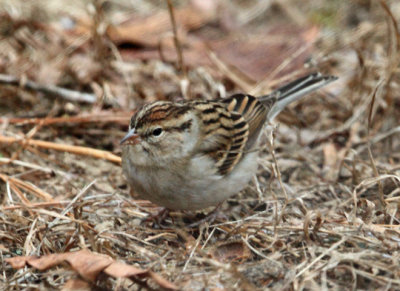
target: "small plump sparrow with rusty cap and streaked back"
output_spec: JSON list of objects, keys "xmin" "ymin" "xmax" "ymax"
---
[{"xmin": 121, "ymin": 73, "xmax": 336, "ymax": 210}]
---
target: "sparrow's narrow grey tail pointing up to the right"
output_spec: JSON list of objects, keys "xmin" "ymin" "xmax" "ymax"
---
[{"xmin": 259, "ymin": 73, "xmax": 337, "ymax": 121}]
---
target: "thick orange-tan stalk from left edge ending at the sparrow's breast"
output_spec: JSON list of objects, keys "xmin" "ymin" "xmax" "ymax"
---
[{"xmin": 0, "ymin": 135, "xmax": 121, "ymax": 164}]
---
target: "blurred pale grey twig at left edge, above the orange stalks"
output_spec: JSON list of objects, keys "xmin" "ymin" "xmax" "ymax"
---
[{"xmin": 0, "ymin": 74, "xmax": 97, "ymax": 103}]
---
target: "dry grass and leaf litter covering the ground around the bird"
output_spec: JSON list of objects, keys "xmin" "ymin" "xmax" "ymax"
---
[{"xmin": 0, "ymin": 0, "xmax": 400, "ymax": 290}]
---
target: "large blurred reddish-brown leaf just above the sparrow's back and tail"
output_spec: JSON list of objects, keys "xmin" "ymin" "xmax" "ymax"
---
[{"xmin": 208, "ymin": 26, "xmax": 318, "ymax": 81}]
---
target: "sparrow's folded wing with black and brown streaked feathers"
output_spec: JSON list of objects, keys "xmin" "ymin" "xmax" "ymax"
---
[{"xmin": 196, "ymin": 94, "xmax": 268, "ymax": 175}]
